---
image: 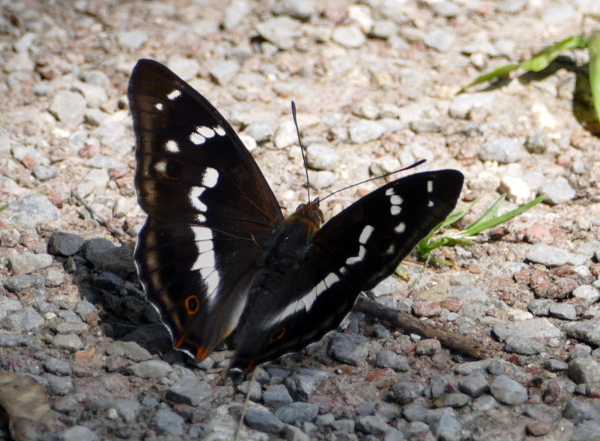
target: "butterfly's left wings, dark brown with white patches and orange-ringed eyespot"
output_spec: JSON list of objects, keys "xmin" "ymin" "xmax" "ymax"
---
[{"xmin": 128, "ymin": 60, "xmax": 282, "ymax": 359}]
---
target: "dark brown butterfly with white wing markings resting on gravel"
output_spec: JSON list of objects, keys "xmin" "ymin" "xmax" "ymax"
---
[{"xmin": 128, "ymin": 60, "xmax": 463, "ymax": 371}]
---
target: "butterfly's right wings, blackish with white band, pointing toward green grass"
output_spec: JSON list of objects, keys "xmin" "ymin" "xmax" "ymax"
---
[{"xmin": 231, "ymin": 170, "xmax": 463, "ymax": 370}]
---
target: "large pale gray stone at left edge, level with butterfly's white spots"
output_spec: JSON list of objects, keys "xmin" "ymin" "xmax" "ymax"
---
[{"xmin": 1, "ymin": 192, "xmax": 61, "ymax": 227}]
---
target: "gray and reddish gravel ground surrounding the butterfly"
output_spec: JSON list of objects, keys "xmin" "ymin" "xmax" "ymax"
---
[{"xmin": 0, "ymin": 0, "xmax": 600, "ymax": 441}]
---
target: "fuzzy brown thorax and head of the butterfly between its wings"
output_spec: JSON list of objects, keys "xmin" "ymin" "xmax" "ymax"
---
[{"xmin": 264, "ymin": 198, "xmax": 323, "ymax": 272}]
